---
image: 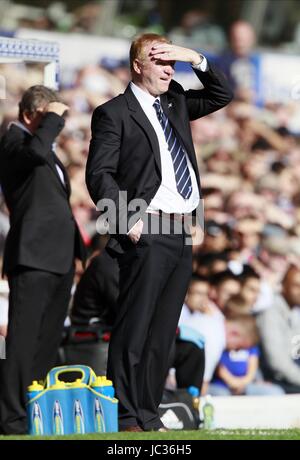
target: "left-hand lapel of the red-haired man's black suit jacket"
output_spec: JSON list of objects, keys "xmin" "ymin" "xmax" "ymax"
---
[{"xmin": 124, "ymin": 86, "xmax": 161, "ymax": 173}]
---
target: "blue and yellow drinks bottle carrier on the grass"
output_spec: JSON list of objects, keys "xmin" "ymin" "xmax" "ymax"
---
[{"xmin": 27, "ymin": 365, "xmax": 118, "ymax": 435}]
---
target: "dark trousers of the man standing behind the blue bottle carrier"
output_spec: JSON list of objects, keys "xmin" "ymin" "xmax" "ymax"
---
[{"xmin": 0, "ymin": 267, "xmax": 74, "ymax": 434}]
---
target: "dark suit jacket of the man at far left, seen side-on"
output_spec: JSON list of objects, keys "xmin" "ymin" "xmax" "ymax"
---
[{"xmin": 0, "ymin": 113, "xmax": 85, "ymax": 274}]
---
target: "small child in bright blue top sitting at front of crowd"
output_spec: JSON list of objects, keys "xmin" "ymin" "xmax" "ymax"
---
[{"xmin": 208, "ymin": 315, "xmax": 284, "ymax": 396}]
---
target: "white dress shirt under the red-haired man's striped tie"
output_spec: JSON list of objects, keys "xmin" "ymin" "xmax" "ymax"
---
[{"xmin": 130, "ymin": 57, "xmax": 207, "ymax": 213}]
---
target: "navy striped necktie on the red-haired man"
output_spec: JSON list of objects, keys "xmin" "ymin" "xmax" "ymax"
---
[{"xmin": 153, "ymin": 99, "xmax": 192, "ymax": 199}]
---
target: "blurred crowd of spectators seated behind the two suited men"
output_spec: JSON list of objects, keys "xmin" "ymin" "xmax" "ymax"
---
[{"xmin": 0, "ymin": 17, "xmax": 300, "ymax": 395}]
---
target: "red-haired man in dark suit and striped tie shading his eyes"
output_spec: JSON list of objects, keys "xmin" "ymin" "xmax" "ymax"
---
[{"xmin": 86, "ymin": 34, "xmax": 232, "ymax": 431}]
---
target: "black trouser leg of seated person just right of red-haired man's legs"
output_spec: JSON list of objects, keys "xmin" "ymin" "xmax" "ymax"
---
[{"xmin": 169, "ymin": 339, "xmax": 205, "ymax": 393}]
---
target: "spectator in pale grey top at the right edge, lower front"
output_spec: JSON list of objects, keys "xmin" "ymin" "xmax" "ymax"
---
[{"xmin": 257, "ymin": 265, "xmax": 300, "ymax": 393}]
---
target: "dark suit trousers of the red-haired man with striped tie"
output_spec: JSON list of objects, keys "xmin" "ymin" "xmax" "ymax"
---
[{"xmin": 107, "ymin": 218, "xmax": 192, "ymax": 430}]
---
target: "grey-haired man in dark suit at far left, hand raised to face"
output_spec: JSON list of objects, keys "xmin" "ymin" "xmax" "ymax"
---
[{"xmin": 0, "ymin": 85, "xmax": 84, "ymax": 434}]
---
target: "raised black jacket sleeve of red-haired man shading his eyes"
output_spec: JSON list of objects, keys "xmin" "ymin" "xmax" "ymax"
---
[{"xmin": 185, "ymin": 63, "xmax": 233, "ymax": 120}]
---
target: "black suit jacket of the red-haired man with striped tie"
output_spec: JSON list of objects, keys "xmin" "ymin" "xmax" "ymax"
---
[{"xmin": 86, "ymin": 65, "xmax": 232, "ymax": 252}]
